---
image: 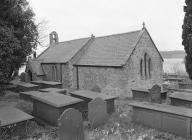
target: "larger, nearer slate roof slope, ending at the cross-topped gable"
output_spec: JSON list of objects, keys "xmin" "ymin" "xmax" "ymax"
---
[{"xmin": 77, "ymin": 30, "xmax": 142, "ymax": 66}]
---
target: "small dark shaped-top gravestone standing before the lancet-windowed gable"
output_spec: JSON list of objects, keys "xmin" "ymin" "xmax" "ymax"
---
[{"xmin": 149, "ymin": 85, "xmax": 161, "ymax": 103}]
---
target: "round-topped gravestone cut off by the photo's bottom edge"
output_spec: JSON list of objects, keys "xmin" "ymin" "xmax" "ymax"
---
[{"xmin": 58, "ymin": 108, "xmax": 84, "ymax": 140}]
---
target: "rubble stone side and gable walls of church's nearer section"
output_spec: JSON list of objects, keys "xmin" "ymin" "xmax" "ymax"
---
[{"xmin": 78, "ymin": 32, "xmax": 163, "ymax": 97}]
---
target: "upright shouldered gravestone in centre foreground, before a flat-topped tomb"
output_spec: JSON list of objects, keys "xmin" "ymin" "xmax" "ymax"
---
[{"xmin": 88, "ymin": 98, "xmax": 107, "ymax": 127}]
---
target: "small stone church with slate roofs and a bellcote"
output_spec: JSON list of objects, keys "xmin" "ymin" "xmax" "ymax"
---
[{"xmin": 26, "ymin": 26, "xmax": 163, "ymax": 96}]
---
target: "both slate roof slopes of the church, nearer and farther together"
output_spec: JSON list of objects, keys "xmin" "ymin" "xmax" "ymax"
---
[{"xmin": 37, "ymin": 28, "xmax": 163, "ymax": 67}]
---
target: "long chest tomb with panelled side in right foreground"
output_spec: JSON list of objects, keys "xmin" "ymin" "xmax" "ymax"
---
[{"xmin": 130, "ymin": 102, "xmax": 192, "ymax": 138}]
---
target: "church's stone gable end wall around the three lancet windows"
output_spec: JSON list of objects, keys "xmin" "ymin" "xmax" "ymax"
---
[{"xmin": 124, "ymin": 32, "xmax": 163, "ymax": 95}]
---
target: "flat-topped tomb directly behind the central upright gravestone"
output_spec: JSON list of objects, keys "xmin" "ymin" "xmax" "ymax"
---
[{"xmin": 70, "ymin": 90, "xmax": 118, "ymax": 114}]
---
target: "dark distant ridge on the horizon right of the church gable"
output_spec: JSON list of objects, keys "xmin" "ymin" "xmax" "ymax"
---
[{"xmin": 160, "ymin": 50, "xmax": 185, "ymax": 59}]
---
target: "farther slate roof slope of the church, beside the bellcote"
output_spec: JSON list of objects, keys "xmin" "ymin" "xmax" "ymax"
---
[{"xmin": 37, "ymin": 37, "xmax": 90, "ymax": 63}]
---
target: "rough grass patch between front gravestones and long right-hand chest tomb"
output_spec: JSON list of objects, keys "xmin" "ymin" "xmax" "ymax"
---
[{"xmin": 87, "ymin": 100, "xmax": 184, "ymax": 140}]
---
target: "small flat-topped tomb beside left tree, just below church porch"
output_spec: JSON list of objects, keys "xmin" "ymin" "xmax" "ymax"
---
[{"xmin": 17, "ymin": 82, "xmax": 40, "ymax": 91}]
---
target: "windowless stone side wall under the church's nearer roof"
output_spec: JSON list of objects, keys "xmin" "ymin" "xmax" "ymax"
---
[{"xmin": 78, "ymin": 67, "xmax": 125, "ymax": 94}]
